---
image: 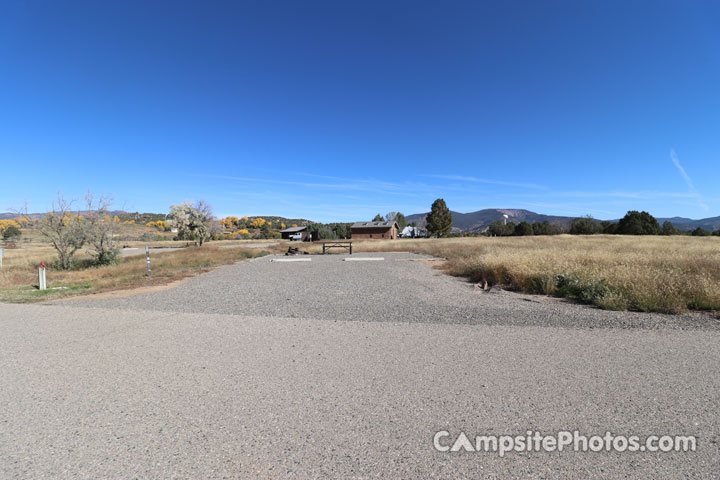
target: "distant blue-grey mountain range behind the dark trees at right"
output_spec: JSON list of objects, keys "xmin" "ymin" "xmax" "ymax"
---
[{"xmin": 405, "ymin": 208, "xmax": 720, "ymax": 233}]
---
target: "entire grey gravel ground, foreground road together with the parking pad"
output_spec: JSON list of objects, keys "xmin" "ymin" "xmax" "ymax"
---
[{"xmin": 0, "ymin": 253, "xmax": 720, "ymax": 479}]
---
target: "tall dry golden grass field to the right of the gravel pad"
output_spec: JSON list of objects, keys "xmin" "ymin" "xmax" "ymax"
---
[{"xmin": 344, "ymin": 235, "xmax": 720, "ymax": 313}]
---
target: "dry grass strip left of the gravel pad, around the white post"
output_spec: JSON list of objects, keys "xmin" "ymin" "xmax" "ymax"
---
[{"xmin": 0, "ymin": 245, "xmax": 278, "ymax": 303}]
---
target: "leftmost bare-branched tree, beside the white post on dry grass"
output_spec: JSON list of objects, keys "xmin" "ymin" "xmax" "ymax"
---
[{"xmin": 38, "ymin": 193, "xmax": 87, "ymax": 270}]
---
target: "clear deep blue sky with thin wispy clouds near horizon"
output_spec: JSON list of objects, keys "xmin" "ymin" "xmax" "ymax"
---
[{"xmin": 0, "ymin": 0, "xmax": 720, "ymax": 221}]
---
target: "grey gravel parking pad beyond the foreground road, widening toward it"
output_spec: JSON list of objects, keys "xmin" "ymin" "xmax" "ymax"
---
[{"xmin": 62, "ymin": 253, "xmax": 720, "ymax": 330}]
